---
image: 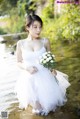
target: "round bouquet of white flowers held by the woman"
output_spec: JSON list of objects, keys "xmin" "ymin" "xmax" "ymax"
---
[{"xmin": 40, "ymin": 51, "xmax": 55, "ymax": 70}]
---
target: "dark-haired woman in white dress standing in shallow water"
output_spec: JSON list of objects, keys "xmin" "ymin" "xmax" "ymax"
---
[{"xmin": 16, "ymin": 15, "xmax": 70, "ymax": 115}]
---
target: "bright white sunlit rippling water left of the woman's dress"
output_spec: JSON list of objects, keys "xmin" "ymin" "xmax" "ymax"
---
[{"xmin": 0, "ymin": 44, "xmax": 17, "ymax": 113}]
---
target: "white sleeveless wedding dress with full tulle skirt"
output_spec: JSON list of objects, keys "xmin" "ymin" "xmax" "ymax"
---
[{"xmin": 15, "ymin": 38, "xmax": 70, "ymax": 113}]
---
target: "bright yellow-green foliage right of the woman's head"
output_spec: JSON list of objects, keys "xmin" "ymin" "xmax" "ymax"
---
[{"xmin": 43, "ymin": 5, "xmax": 80, "ymax": 41}]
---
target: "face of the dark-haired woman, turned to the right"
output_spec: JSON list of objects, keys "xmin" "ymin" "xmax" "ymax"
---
[{"xmin": 28, "ymin": 21, "xmax": 42, "ymax": 39}]
